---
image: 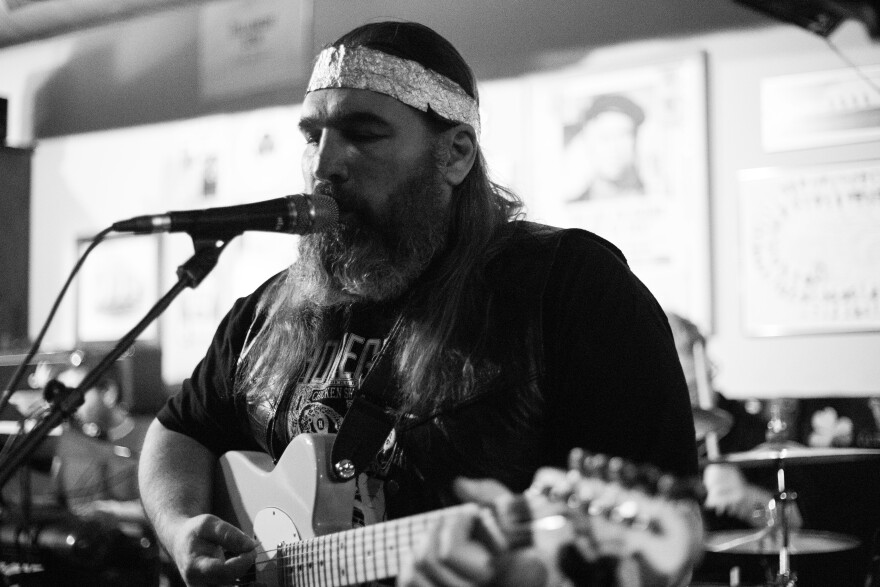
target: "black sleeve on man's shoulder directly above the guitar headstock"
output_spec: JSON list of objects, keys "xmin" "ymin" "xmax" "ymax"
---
[{"xmin": 543, "ymin": 230, "xmax": 698, "ymax": 476}]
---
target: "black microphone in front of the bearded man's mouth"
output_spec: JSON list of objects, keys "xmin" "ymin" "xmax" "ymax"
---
[{"xmin": 111, "ymin": 194, "xmax": 339, "ymax": 238}]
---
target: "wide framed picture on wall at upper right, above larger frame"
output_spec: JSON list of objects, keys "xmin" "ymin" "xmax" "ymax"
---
[{"xmin": 761, "ymin": 65, "xmax": 880, "ymax": 152}]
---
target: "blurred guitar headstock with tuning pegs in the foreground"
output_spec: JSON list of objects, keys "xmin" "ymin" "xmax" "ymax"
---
[{"xmin": 527, "ymin": 449, "xmax": 703, "ymax": 587}]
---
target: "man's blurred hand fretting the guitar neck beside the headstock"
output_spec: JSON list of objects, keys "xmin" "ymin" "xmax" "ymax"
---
[{"xmin": 397, "ymin": 479, "xmax": 547, "ymax": 587}]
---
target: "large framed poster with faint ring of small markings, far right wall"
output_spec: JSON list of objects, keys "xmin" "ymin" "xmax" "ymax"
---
[{"xmin": 739, "ymin": 161, "xmax": 880, "ymax": 336}]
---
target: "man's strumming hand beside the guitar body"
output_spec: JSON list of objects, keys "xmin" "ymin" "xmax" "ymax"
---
[{"xmin": 171, "ymin": 514, "xmax": 257, "ymax": 586}]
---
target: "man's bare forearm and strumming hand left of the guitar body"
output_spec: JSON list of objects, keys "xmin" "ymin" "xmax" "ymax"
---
[{"xmin": 138, "ymin": 420, "xmax": 256, "ymax": 585}]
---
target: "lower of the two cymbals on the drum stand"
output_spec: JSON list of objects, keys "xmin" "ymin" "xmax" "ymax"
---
[{"xmin": 704, "ymin": 529, "xmax": 861, "ymax": 554}]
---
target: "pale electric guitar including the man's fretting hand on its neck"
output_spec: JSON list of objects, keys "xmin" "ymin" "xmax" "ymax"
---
[{"xmin": 210, "ymin": 434, "xmax": 702, "ymax": 587}]
